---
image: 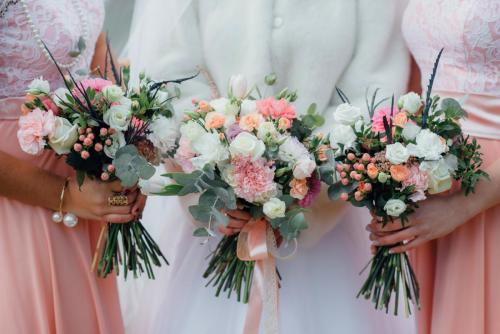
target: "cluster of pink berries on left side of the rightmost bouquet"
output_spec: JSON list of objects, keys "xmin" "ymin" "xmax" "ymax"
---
[{"xmin": 336, "ymin": 153, "xmax": 375, "ymax": 202}]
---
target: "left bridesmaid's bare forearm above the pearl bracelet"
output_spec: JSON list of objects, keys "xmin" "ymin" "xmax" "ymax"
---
[{"xmin": 0, "ymin": 151, "xmax": 64, "ymax": 210}]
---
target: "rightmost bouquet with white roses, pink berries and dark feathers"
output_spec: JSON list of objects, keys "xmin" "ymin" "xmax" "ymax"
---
[{"xmin": 329, "ymin": 49, "xmax": 487, "ymax": 314}]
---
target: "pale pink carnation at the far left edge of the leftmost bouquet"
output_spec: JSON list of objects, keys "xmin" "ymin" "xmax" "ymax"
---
[{"xmin": 17, "ymin": 108, "xmax": 55, "ymax": 155}]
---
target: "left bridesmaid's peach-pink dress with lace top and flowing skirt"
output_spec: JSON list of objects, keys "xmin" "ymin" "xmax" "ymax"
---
[{"xmin": 0, "ymin": 0, "xmax": 123, "ymax": 334}]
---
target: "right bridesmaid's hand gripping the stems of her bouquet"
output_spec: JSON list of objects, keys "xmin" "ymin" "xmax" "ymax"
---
[{"xmin": 366, "ymin": 194, "xmax": 474, "ymax": 253}]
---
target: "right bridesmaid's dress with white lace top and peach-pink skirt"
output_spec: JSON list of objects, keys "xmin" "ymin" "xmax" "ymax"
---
[{"xmin": 403, "ymin": 0, "xmax": 500, "ymax": 334}]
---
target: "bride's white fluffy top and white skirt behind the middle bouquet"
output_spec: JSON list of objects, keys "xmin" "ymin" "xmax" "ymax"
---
[{"xmin": 121, "ymin": 0, "xmax": 414, "ymax": 334}]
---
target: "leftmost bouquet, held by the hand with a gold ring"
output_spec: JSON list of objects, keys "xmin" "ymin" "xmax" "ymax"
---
[{"xmin": 18, "ymin": 45, "xmax": 189, "ymax": 278}]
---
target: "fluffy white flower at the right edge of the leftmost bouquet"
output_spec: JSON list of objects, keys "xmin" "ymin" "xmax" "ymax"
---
[{"xmin": 148, "ymin": 116, "xmax": 179, "ymax": 153}]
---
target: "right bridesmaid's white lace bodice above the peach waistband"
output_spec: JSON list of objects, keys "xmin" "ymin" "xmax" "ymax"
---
[{"xmin": 403, "ymin": 0, "xmax": 500, "ymax": 96}]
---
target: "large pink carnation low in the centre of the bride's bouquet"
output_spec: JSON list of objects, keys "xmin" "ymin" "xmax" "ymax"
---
[{"xmin": 231, "ymin": 156, "xmax": 276, "ymax": 203}]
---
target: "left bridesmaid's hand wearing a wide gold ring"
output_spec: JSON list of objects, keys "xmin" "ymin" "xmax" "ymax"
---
[{"xmin": 63, "ymin": 180, "xmax": 144, "ymax": 223}]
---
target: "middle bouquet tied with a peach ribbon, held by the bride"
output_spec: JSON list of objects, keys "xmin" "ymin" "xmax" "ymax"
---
[{"xmin": 162, "ymin": 75, "xmax": 335, "ymax": 332}]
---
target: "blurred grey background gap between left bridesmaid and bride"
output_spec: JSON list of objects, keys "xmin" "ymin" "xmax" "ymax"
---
[{"xmin": 104, "ymin": 0, "xmax": 135, "ymax": 55}]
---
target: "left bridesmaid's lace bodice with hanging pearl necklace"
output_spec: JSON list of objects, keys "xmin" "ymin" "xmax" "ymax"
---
[{"xmin": 0, "ymin": 0, "xmax": 104, "ymax": 99}]
